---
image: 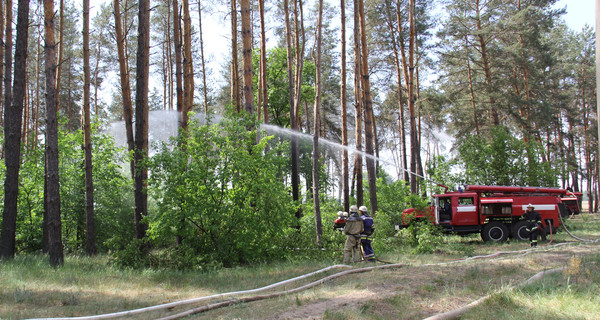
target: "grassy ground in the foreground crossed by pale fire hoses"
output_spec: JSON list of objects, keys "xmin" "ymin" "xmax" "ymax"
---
[{"xmin": 0, "ymin": 215, "xmax": 600, "ymax": 319}]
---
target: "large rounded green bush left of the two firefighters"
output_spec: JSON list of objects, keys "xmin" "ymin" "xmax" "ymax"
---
[{"xmin": 148, "ymin": 111, "xmax": 294, "ymax": 267}]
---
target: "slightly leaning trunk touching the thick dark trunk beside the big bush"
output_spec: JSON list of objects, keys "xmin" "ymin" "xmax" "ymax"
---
[{"xmin": 113, "ymin": 0, "xmax": 135, "ymax": 178}]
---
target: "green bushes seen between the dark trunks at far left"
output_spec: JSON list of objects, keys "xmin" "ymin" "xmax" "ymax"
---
[{"xmin": 0, "ymin": 119, "xmax": 133, "ymax": 252}]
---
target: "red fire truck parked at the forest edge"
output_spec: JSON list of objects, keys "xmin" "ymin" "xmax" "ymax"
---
[{"xmin": 400, "ymin": 185, "xmax": 581, "ymax": 242}]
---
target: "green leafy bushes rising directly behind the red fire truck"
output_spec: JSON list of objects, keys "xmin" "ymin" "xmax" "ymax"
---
[{"xmin": 458, "ymin": 126, "xmax": 557, "ymax": 187}]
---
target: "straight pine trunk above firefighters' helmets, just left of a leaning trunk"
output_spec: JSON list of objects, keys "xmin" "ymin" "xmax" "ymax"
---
[{"xmin": 353, "ymin": 0, "xmax": 364, "ymax": 206}]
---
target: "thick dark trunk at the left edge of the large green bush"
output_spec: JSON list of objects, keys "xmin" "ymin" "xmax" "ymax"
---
[{"xmin": 134, "ymin": 0, "xmax": 150, "ymax": 239}]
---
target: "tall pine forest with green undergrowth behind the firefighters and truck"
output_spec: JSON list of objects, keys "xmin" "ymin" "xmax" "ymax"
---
[{"xmin": 0, "ymin": 0, "xmax": 600, "ymax": 269}]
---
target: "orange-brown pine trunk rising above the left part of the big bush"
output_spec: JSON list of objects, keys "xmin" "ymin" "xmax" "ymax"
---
[{"xmin": 181, "ymin": 0, "xmax": 194, "ymax": 127}]
